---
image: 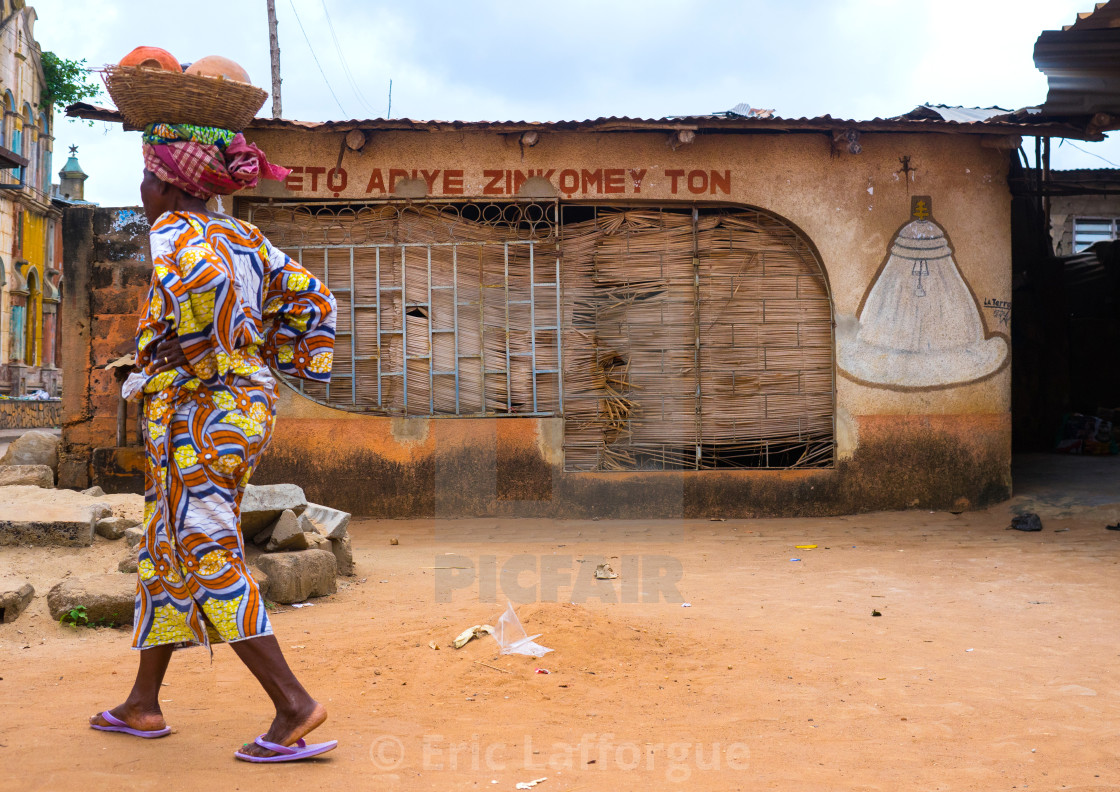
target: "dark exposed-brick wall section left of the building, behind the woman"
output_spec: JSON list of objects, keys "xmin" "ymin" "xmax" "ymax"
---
[{"xmin": 58, "ymin": 207, "xmax": 151, "ymax": 492}]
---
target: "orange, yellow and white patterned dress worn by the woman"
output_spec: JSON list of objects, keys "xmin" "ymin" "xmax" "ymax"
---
[{"xmin": 125, "ymin": 212, "xmax": 335, "ymax": 649}]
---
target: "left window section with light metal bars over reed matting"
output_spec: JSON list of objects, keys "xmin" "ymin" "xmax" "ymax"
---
[{"xmin": 242, "ymin": 202, "xmax": 563, "ymax": 416}]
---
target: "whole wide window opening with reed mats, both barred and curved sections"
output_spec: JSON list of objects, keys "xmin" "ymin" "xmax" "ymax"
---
[{"xmin": 245, "ymin": 201, "xmax": 836, "ymax": 470}]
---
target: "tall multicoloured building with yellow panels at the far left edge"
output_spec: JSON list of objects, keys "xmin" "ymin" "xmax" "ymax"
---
[{"xmin": 0, "ymin": 0, "xmax": 62, "ymax": 397}]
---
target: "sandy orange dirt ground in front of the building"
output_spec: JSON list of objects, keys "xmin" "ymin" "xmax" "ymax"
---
[{"xmin": 0, "ymin": 457, "xmax": 1120, "ymax": 792}]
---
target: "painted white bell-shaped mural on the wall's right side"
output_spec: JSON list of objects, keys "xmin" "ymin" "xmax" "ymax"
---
[{"xmin": 837, "ymin": 196, "xmax": 1009, "ymax": 390}]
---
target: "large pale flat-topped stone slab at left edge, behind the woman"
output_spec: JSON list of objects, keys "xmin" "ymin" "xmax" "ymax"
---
[{"xmin": 0, "ymin": 486, "xmax": 105, "ymax": 547}]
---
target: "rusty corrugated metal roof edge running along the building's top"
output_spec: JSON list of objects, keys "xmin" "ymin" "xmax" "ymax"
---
[{"xmin": 66, "ymin": 102, "xmax": 1103, "ymax": 140}]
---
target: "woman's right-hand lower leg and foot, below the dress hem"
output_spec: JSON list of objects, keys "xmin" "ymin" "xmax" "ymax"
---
[{"xmin": 230, "ymin": 635, "xmax": 327, "ymax": 756}]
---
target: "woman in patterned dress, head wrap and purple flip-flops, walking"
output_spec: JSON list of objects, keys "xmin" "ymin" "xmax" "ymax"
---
[{"xmin": 90, "ymin": 119, "xmax": 337, "ymax": 762}]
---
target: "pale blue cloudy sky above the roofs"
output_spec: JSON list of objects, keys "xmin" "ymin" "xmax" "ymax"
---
[{"xmin": 31, "ymin": 0, "xmax": 1120, "ymax": 205}]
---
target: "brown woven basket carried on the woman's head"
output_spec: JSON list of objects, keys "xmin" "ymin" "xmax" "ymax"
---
[{"xmin": 101, "ymin": 66, "xmax": 269, "ymax": 131}]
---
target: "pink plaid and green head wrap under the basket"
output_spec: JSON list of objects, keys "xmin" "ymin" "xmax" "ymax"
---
[{"xmin": 143, "ymin": 123, "xmax": 291, "ymax": 201}]
